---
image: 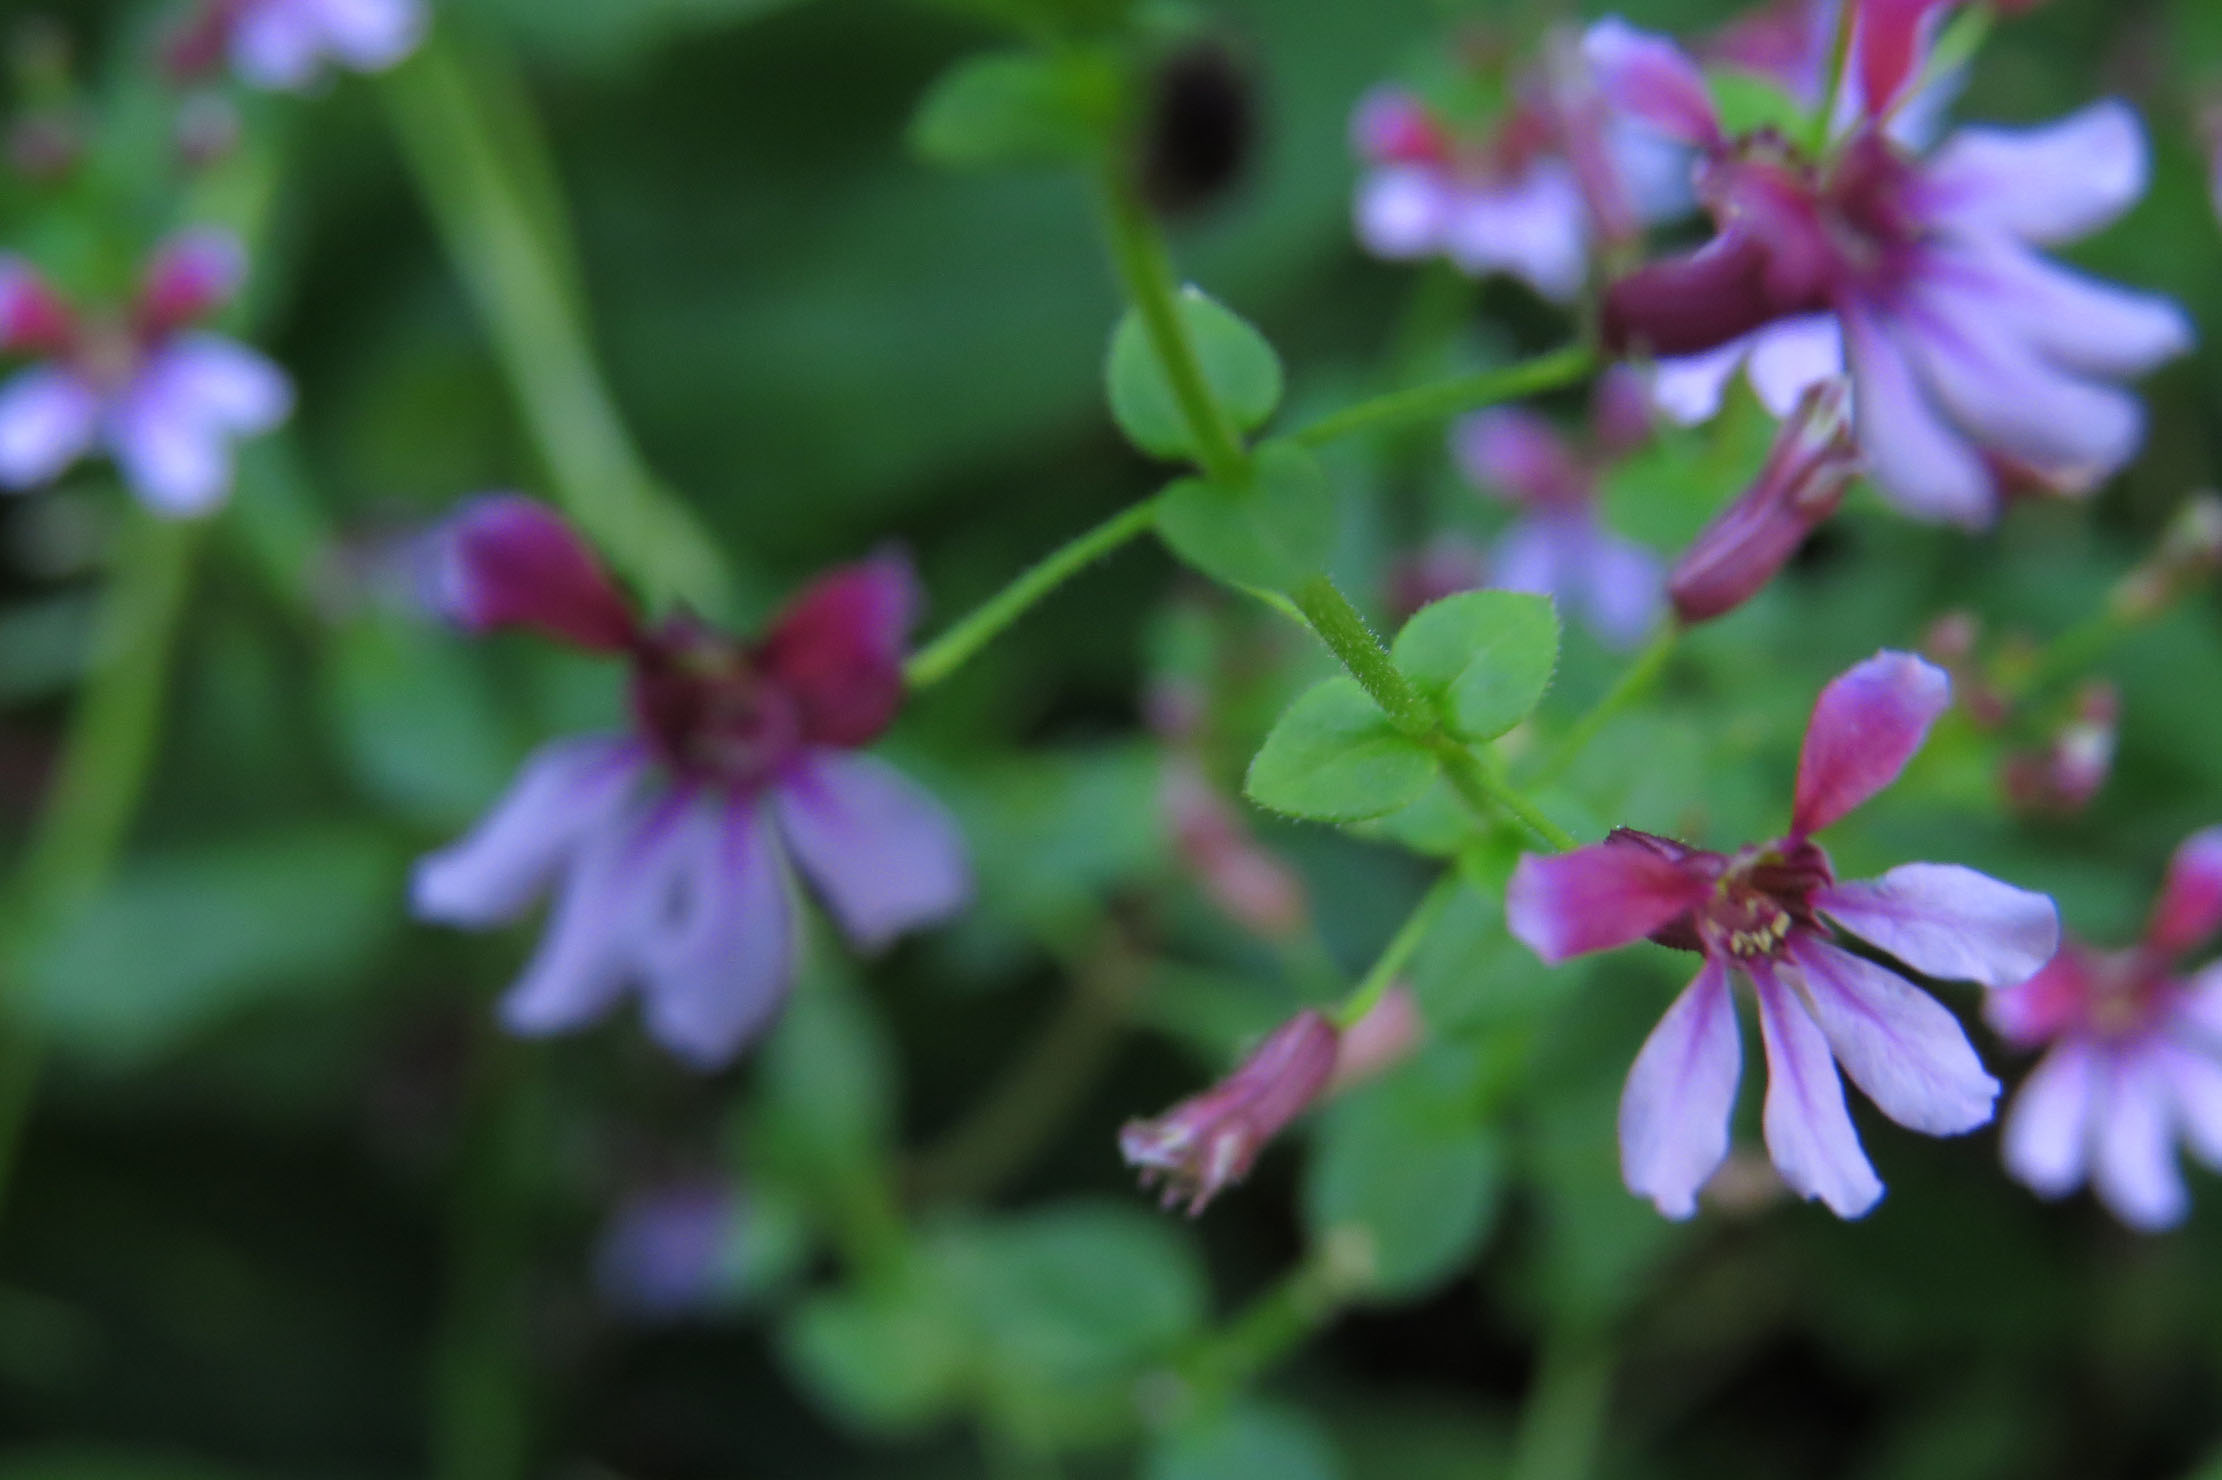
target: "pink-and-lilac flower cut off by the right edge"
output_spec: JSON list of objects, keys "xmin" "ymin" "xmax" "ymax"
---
[{"xmin": 1989, "ymin": 827, "xmax": 2222, "ymax": 1229}]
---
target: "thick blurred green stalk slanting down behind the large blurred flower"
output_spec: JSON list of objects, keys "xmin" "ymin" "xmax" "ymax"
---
[{"xmin": 380, "ymin": 31, "xmax": 731, "ymax": 613}]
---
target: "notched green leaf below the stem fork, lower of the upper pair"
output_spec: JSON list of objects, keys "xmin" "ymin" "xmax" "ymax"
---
[{"xmin": 1158, "ymin": 442, "xmax": 1335, "ymax": 591}]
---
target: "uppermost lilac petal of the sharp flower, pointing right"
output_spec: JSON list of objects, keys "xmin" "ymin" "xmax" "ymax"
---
[{"xmin": 1813, "ymin": 864, "xmax": 2060, "ymax": 987}]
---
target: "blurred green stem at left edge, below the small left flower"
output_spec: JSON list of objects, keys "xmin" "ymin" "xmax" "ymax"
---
[{"xmin": 0, "ymin": 509, "xmax": 200, "ymax": 1200}]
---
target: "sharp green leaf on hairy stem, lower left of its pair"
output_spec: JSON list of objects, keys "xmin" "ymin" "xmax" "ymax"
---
[{"xmin": 1242, "ymin": 678, "xmax": 1435, "ymax": 822}]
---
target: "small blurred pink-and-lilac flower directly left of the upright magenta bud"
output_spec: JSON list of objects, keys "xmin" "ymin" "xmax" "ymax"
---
[{"xmin": 1451, "ymin": 373, "xmax": 1662, "ymax": 647}]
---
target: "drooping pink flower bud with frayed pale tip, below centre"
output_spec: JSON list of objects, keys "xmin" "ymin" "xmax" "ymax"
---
[{"xmin": 1118, "ymin": 1009, "xmax": 1340, "ymax": 1218}]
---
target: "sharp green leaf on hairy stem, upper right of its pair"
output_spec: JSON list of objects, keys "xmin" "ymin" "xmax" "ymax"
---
[{"xmin": 1389, "ymin": 591, "xmax": 1558, "ymax": 740}]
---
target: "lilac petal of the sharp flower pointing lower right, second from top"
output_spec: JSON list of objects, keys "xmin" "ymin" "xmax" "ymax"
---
[{"xmin": 1791, "ymin": 936, "xmax": 1998, "ymax": 1136}]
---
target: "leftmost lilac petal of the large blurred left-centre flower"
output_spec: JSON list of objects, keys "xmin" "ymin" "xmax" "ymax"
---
[{"xmin": 409, "ymin": 736, "xmax": 642, "ymax": 927}]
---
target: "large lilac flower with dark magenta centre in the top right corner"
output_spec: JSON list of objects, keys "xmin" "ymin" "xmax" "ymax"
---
[{"xmin": 1587, "ymin": 10, "xmax": 2191, "ymax": 527}]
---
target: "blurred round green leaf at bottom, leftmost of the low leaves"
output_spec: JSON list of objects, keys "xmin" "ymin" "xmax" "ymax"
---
[{"xmin": 780, "ymin": 1269, "xmax": 971, "ymax": 1436}]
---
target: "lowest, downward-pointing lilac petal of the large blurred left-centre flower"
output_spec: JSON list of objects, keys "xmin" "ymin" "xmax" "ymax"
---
[{"xmin": 640, "ymin": 804, "xmax": 795, "ymax": 1069}]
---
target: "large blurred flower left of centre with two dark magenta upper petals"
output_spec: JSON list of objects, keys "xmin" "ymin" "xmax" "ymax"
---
[{"xmin": 413, "ymin": 496, "xmax": 971, "ymax": 1069}]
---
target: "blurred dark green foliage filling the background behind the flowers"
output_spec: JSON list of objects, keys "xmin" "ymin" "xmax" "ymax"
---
[{"xmin": 0, "ymin": 0, "xmax": 2222, "ymax": 1480}]
